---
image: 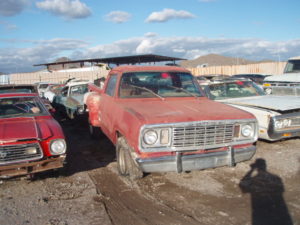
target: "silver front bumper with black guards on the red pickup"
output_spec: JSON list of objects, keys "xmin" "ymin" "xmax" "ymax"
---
[{"xmin": 136, "ymin": 145, "xmax": 256, "ymax": 173}]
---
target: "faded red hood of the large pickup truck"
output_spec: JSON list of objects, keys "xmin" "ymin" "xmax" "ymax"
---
[{"xmin": 119, "ymin": 97, "xmax": 254, "ymax": 124}]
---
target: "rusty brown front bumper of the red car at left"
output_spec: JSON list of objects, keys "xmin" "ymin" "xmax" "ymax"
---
[{"xmin": 0, "ymin": 155, "xmax": 66, "ymax": 178}]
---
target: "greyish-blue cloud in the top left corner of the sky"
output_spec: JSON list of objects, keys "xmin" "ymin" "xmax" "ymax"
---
[{"xmin": 0, "ymin": 0, "xmax": 29, "ymax": 16}]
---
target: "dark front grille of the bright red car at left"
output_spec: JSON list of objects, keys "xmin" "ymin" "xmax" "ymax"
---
[{"xmin": 0, "ymin": 143, "xmax": 43, "ymax": 165}]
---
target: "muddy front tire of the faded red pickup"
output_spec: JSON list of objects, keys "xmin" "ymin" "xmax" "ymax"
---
[{"xmin": 116, "ymin": 137, "xmax": 144, "ymax": 180}]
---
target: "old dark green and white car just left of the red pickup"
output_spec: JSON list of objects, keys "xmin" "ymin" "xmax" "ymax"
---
[{"xmin": 52, "ymin": 81, "xmax": 89, "ymax": 119}]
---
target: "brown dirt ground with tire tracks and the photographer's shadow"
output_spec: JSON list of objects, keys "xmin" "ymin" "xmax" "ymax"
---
[{"xmin": 0, "ymin": 118, "xmax": 300, "ymax": 225}]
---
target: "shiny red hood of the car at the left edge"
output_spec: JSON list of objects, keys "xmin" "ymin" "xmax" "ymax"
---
[{"xmin": 0, "ymin": 117, "xmax": 53, "ymax": 143}]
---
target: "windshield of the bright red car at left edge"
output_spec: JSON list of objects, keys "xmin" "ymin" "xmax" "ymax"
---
[{"xmin": 0, "ymin": 97, "xmax": 48, "ymax": 118}]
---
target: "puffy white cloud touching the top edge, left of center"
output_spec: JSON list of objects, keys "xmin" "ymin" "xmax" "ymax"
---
[{"xmin": 36, "ymin": 0, "xmax": 91, "ymax": 19}]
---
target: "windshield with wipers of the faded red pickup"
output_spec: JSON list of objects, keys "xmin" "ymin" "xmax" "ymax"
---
[{"xmin": 119, "ymin": 72, "xmax": 202, "ymax": 98}]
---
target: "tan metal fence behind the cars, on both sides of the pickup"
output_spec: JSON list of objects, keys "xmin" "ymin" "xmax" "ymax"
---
[{"xmin": 10, "ymin": 62, "xmax": 286, "ymax": 84}]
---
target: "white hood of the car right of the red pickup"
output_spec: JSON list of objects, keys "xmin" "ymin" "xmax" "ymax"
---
[{"xmin": 220, "ymin": 95, "xmax": 300, "ymax": 111}]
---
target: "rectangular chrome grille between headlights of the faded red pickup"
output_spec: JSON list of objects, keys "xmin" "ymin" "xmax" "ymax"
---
[{"xmin": 172, "ymin": 121, "xmax": 234, "ymax": 149}]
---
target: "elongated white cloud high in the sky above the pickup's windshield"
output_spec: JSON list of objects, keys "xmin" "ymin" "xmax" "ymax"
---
[{"xmin": 146, "ymin": 9, "xmax": 196, "ymax": 23}]
